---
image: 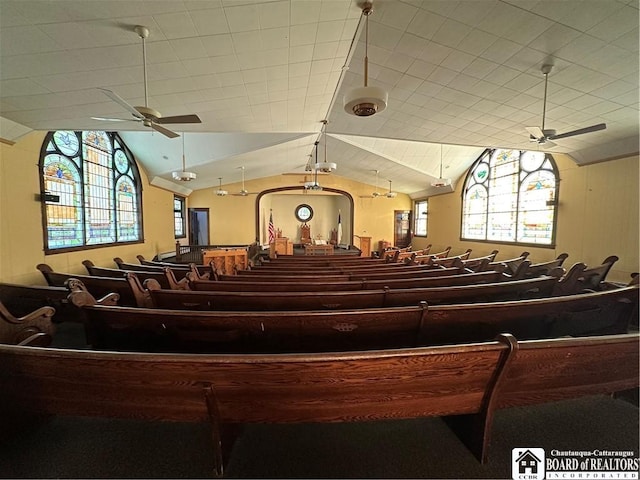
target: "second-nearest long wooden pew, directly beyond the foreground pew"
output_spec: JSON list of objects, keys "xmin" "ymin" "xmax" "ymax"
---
[{"xmin": 70, "ymin": 278, "xmax": 638, "ymax": 353}]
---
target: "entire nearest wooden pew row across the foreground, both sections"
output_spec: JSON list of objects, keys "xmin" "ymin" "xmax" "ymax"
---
[{"xmin": 0, "ymin": 334, "xmax": 639, "ymax": 477}]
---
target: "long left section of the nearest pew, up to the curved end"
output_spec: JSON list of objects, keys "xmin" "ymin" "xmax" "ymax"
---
[{"xmin": 0, "ymin": 336, "xmax": 507, "ymax": 477}]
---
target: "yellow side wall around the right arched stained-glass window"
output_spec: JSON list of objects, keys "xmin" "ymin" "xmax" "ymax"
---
[{"xmin": 413, "ymin": 154, "xmax": 640, "ymax": 282}]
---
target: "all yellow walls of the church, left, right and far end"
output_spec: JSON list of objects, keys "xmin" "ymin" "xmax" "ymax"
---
[{"xmin": 0, "ymin": 132, "xmax": 640, "ymax": 284}]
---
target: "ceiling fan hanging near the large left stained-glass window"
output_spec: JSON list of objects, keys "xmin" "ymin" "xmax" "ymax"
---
[{"xmin": 91, "ymin": 25, "xmax": 202, "ymax": 138}]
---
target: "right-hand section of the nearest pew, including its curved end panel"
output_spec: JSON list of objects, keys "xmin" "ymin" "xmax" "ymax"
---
[{"xmin": 444, "ymin": 333, "xmax": 640, "ymax": 463}]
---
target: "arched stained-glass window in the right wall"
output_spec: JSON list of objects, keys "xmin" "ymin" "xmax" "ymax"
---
[{"xmin": 461, "ymin": 149, "xmax": 559, "ymax": 246}]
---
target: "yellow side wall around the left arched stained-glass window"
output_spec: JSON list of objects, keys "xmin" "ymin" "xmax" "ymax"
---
[{"xmin": 0, "ymin": 132, "xmax": 175, "ymax": 284}]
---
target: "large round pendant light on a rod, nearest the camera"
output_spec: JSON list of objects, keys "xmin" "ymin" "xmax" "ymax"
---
[{"xmin": 344, "ymin": 1, "xmax": 389, "ymax": 117}]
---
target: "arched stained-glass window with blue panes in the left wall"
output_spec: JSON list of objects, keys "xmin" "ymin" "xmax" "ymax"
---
[{"xmin": 40, "ymin": 131, "xmax": 142, "ymax": 253}]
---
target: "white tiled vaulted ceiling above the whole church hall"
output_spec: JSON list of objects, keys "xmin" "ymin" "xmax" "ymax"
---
[{"xmin": 0, "ymin": 0, "xmax": 640, "ymax": 197}]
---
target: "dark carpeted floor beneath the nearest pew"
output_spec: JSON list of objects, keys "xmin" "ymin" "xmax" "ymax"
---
[{"xmin": 0, "ymin": 396, "xmax": 639, "ymax": 479}]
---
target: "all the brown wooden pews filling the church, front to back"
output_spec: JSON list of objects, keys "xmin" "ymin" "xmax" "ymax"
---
[{"xmin": 0, "ymin": 251, "xmax": 640, "ymax": 476}]
